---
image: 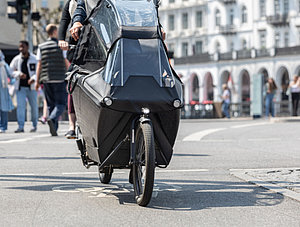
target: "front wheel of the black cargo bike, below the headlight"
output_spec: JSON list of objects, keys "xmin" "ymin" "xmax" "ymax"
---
[{"xmin": 132, "ymin": 122, "xmax": 155, "ymax": 206}]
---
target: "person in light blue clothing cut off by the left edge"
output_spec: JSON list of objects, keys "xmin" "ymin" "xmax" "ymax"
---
[{"xmin": 0, "ymin": 50, "xmax": 14, "ymax": 133}]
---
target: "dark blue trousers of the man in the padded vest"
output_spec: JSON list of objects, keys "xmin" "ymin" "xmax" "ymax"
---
[{"xmin": 44, "ymin": 82, "xmax": 67, "ymax": 130}]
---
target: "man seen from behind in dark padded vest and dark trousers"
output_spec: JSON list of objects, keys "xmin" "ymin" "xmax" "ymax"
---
[{"xmin": 36, "ymin": 24, "xmax": 69, "ymax": 136}]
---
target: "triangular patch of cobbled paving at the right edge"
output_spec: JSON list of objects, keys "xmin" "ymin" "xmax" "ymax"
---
[{"xmin": 230, "ymin": 167, "xmax": 300, "ymax": 201}]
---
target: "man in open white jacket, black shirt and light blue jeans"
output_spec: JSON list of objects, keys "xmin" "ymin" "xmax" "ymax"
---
[{"xmin": 10, "ymin": 40, "xmax": 38, "ymax": 133}]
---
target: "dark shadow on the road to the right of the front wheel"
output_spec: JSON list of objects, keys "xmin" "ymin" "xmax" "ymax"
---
[{"xmin": 150, "ymin": 180, "xmax": 283, "ymax": 211}]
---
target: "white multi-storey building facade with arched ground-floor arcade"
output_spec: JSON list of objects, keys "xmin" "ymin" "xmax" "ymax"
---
[{"xmin": 159, "ymin": 0, "xmax": 300, "ymax": 115}]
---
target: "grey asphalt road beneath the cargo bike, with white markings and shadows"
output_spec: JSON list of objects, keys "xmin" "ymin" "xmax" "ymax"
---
[{"xmin": 0, "ymin": 120, "xmax": 300, "ymax": 227}]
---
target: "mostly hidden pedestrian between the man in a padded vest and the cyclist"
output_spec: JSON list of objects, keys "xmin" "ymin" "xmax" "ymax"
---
[{"xmin": 58, "ymin": 0, "xmax": 77, "ymax": 139}]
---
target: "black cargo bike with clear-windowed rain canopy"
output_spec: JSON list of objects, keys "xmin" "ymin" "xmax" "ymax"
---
[{"xmin": 68, "ymin": 0, "xmax": 183, "ymax": 206}]
